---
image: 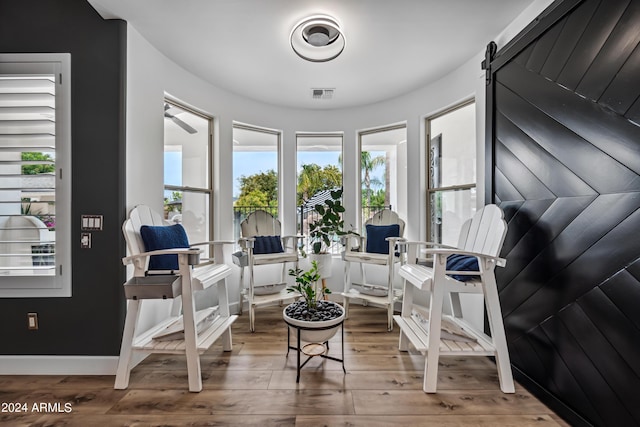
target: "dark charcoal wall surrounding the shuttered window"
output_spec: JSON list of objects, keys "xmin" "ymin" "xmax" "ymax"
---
[{"xmin": 0, "ymin": 0, "xmax": 126, "ymax": 355}]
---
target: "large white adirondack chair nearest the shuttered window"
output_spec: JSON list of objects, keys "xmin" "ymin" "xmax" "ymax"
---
[{"xmin": 114, "ymin": 205, "xmax": 237, "ymax": 392}]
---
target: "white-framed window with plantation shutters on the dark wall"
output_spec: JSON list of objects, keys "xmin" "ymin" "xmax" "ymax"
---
[{"xmin": 0, "ymin": 54, "xmax": 71, "ymax": 297}]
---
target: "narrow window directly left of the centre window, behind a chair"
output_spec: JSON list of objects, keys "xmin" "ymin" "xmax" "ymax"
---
[{"xmin": 233, "ymin": 123, "xmax": 280, "ymax": 242}]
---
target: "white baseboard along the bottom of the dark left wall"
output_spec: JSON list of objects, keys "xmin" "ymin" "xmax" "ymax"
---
[{"xmin": 0, "ymin": 354, "xmax": 147, "ymax": 375}]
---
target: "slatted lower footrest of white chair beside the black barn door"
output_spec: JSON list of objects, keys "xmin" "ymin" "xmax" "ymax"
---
[{"xmin": 393, "ymin": 316, "xmax": 495, "ymax": 356}]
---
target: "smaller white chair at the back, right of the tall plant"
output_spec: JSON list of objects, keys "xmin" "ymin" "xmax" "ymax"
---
[{"xmin": 342, "ymin": 209, "xmax": 405, "ymax": 331}]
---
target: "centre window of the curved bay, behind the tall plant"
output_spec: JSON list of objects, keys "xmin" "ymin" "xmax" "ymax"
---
[{"xmin": 296, "ymin": 133, "xmax": 344, "ymax": 254}]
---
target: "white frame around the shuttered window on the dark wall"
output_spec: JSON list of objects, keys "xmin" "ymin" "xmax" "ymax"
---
[{"xmin": 0, "ymin": 53, "xmax": 72, "ymax": 298}]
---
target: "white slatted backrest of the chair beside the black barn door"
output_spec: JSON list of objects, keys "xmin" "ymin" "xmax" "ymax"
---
[{"xmin": 458, "ymin": 205, "xmax": 507, "ymax": 256}]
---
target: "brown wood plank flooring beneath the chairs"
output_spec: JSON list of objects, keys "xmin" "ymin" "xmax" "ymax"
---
[{"xmin": 0, "ymin": 304, "xmax": 567, "ymax": 427}]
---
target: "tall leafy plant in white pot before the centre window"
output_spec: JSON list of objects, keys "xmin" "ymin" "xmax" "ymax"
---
[{"xmin": 309, "ymin": 188, "xmax": 346, "ymax": 278}]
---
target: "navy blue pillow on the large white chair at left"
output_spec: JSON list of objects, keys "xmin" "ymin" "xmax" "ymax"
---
[{"xmin": 140, "ymin": 224, "xmax": 189, "ymax": 270}]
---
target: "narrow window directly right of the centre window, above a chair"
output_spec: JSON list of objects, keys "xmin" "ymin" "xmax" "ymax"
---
[{"xmin": 359, "ymin": 124, "xmax": 407, "ymax": 231}]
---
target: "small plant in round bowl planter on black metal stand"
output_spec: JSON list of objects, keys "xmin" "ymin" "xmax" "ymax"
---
[{"xmin": 283, "ymin": 261, "xmax": 344, "ymax": 343}]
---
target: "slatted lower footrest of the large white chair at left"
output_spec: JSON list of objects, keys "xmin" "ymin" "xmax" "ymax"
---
[{"xmin": 133, "ymin": 307, "xmax": 238, "ymax": 354}]
